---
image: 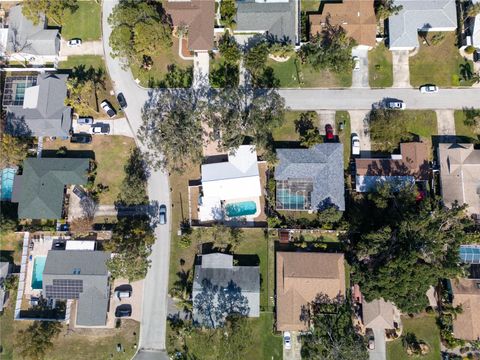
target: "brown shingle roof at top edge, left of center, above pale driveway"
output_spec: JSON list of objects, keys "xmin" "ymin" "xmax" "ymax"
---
[{"xmin": 165, "ymin": 0, "xmax": 215, "ymax": 51}]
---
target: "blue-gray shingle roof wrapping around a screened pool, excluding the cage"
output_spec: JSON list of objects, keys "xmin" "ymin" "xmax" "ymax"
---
[{"xmin": 275, "ymin": 143, "xmax": 345, "ymax": 211}]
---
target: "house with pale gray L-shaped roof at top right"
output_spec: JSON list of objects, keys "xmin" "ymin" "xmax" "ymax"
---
[{"xmin": 388, "ymin": 0, "xmax": 457, "ymax": 50}]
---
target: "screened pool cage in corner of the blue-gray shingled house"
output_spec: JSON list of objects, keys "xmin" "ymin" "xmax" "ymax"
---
[{"xmin": 275, "ymin": 179, "xmax": 313, "ymax": 211}]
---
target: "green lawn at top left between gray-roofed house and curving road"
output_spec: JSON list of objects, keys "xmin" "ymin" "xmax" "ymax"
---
[{"xmin": 62, "ymin": 0, "xmax": 102, "ymax": 41}]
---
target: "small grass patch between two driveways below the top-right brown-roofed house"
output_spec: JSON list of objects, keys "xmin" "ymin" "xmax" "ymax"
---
[{"xmin": 368, "ymin": 44, "xmax": 393, "ymax": 88}]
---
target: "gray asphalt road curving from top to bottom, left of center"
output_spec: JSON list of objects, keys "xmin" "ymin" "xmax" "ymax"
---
[{"xmin": 102, "ymin": 0, "xmax": 171, "ymax": 359}]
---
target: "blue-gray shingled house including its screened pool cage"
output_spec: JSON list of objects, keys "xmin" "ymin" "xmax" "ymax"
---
[{"xmin": 274, "ymin": 143, "xmax": 345, "ymax": 211}]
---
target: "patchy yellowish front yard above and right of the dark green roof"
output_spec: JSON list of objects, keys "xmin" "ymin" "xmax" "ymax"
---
[{"xmin": 44, "ymin": 135, "xmax": 135, "ymax": 205}]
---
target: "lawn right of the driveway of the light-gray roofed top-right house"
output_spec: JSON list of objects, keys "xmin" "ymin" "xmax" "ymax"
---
[{"xmin": 410, "ymin": 31, "xmax": 473, "ymax": 86}]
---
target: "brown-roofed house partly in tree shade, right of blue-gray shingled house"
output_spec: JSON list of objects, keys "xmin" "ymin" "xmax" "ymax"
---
[{"xmin": 355, "ymin": 142, "xmax": 430, "ymax": 192}]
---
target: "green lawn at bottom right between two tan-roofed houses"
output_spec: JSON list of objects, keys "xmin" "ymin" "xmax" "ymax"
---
[{"xmin": 387, "ymin": 314, "xmax": 440, "ymax": 360}]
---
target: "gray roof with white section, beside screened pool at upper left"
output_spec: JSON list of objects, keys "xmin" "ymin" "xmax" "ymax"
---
[{"xmin": 6, "ymin": 72, "xmax": 72, "ymax": 137}]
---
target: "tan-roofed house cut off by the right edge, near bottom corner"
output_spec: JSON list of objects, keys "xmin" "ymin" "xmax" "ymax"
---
[{"xmin": 450, "ymin": 279, "xmax": 480, "ymax": 341}]
